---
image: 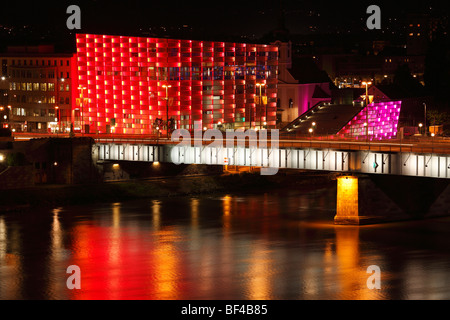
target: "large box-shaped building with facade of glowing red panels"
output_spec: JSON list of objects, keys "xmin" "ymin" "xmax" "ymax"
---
[{"xmin": 74, "ymin": 34, "xmax": 278, "ymax": 134}]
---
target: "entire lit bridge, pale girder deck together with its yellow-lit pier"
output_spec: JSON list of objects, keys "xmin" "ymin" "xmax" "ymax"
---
[{"xmin": 8, "ymin": 131, "xmax": 450, "ymax": 224}]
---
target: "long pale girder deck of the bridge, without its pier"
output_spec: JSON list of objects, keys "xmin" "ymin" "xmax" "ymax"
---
[{"xmin": 95, "ymin": 138, "xmax": 450, "ymax": 179}]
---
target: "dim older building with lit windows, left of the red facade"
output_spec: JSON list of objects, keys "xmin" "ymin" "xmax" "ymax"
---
[{"xmin": 0, "ymin": 46, "xmax": 77, "ymax": 133}]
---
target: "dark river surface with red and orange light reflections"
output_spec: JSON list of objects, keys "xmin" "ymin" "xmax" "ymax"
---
[{"xmin": 0, "ymin": 188, "xmax": 450, "ymax": 299}]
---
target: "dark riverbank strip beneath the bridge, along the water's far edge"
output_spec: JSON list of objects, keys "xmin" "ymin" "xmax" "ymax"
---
[{"xmin": 0, "ymin": 172, "xmax": 335, "ymax": 214}]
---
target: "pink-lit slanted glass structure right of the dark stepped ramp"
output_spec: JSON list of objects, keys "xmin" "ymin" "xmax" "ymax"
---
[{"xmin": 338, "ymin": 101, "xmax": 401, "ymax": 140}]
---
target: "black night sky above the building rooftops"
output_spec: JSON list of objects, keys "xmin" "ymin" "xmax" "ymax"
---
[{"xmin": 0, "ymin": 0, "xmax": 450, "ymax": 49}]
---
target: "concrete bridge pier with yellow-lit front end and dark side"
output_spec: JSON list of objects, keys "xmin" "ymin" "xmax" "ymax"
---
[{"xmin": 334, "ymin": 174, "xmax": 450, "ymax": 225}]
